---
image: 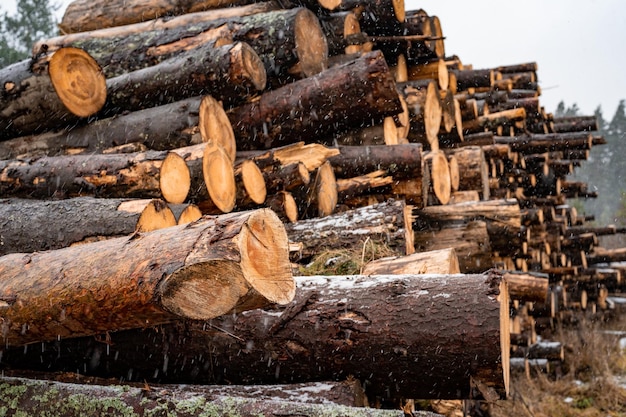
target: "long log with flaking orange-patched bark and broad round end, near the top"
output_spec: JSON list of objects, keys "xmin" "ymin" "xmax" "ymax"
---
[{"xmin": 39, "ymin": 8, "xmax": 328, "ymax": 78}]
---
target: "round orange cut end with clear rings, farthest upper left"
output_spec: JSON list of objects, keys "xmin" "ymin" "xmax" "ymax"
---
[{"xmin": 48, "ymin": 48, "xmax": 107, "ymax": 117}]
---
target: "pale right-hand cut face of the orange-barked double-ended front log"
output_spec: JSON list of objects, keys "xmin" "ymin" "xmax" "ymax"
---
[{"xmin": 239, "ymin": 209, "xmax": 296, "ymax": 304}]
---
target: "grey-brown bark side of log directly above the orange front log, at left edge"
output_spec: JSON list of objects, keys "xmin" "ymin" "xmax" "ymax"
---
[{"xmin": 0, "ymin": 197, "xmax": 150, "ymax": 255}]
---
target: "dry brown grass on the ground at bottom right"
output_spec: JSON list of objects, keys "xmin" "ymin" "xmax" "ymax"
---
[{"xmin": 489, "ymin": 318, "xmax": 626, "ymax": 417}]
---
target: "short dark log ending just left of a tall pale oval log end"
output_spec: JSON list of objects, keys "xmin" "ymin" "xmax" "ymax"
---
[{"xmin": 328, "ymin": 143, "xmax": 424, "ymax": 179}]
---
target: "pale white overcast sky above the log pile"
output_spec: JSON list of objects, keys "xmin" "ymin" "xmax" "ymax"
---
[{"xmin": 0, "ymin": 0, "xmax": 626, "ymax": 119}]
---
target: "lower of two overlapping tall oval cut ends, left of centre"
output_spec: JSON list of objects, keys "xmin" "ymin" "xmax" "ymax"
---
[{"xmin": 202, "ymin": 146, "xmax": 237, "ymax": 213}]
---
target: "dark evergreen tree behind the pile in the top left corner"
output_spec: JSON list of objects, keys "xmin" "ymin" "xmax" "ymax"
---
[{"xmin": 0, "ymin": 0, "xmax": 59, "ymax": 67}]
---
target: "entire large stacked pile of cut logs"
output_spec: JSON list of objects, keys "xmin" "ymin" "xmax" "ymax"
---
[{"xmin": 0, "ymin": 0, "xmax": 626, "ymax": 415}]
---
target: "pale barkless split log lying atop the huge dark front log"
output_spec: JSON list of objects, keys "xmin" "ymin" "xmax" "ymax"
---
[{"xmin": 362, "ymin": 248, "xmax": 461, "ymax": 275}]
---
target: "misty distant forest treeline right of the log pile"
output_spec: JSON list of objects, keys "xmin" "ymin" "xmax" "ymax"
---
[{"xmin": 554, "ymin": 100, "xmax": 626, "ymax": 237}]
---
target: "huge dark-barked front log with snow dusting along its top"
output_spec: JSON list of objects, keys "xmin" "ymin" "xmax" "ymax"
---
[{"xmin": 3, "ymin": 271, "xmax": 510, "ymax": 400}]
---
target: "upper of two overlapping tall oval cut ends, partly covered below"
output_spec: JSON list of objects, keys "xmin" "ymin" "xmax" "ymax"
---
[{"xmin": 198, "ymin": 96, "xmax": 237, "ymax": 162}]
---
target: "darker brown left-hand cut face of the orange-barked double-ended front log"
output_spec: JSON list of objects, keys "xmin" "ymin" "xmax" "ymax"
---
[{"xmin": 159, "ymin": 260, "xmax": 248, "ymax": 320}]
